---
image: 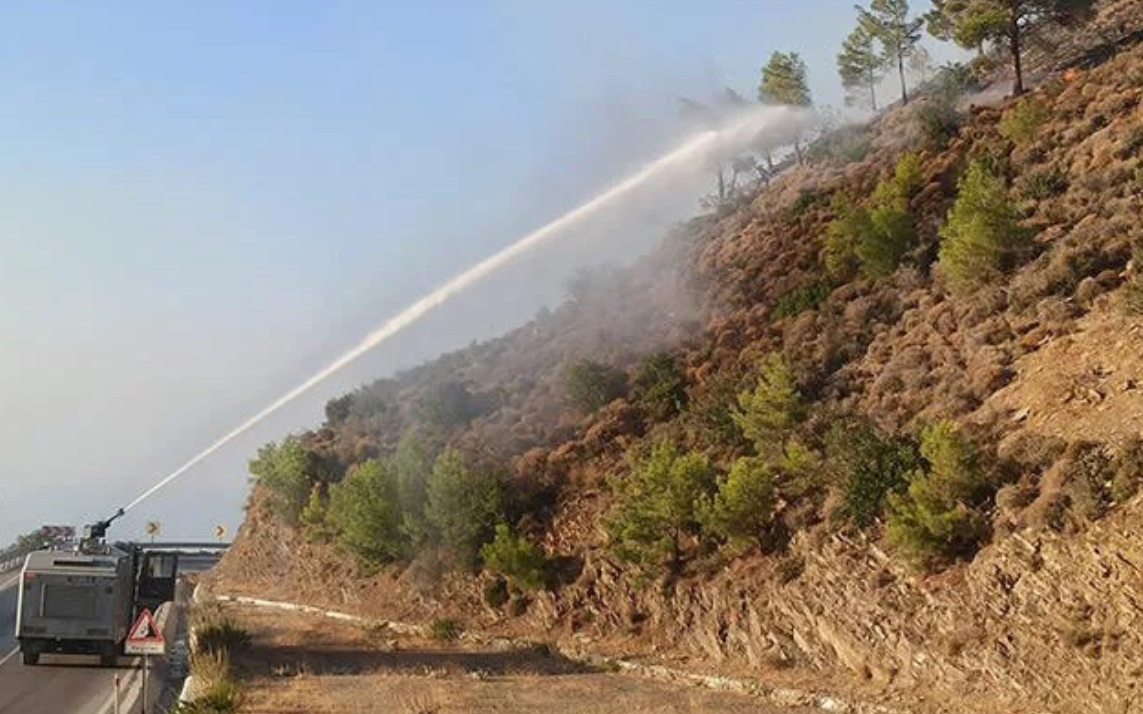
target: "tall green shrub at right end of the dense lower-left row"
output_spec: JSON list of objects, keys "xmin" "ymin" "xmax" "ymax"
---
[{"xmin": 425, "ymin": 449, "xmax": 504, "ymax": 567}]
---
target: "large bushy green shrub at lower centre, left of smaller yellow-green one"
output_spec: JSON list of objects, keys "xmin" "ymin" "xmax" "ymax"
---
[{"xmin": 608, "ymin": 441, "xmax": 714, "ymax": 572}]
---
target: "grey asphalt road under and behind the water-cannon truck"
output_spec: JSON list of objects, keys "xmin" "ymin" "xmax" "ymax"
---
[{"xmin": 0, "ymin": 572, "xmax": 138, "ymax": 714}]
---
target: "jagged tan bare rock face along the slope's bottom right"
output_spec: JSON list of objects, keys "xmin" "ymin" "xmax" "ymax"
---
[{"xmin": 533, "ymin": 500, "xmax": 1143, "ymax": 714}]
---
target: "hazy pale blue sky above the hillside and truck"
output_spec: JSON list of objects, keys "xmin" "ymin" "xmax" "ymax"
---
[{"xmin": 0, "ymin": 0, "xmax": 955, "ymax": 540}]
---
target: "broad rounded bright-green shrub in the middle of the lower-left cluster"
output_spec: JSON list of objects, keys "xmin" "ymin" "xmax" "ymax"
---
[{"xmin": 327, "ymin": 459, "xmax": 408, "ymax": 564}]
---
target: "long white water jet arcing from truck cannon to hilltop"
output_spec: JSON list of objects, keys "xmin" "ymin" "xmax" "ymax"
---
[{"xmin": 123, "ymin": 107, "xmax": 790, "ymax": 511}]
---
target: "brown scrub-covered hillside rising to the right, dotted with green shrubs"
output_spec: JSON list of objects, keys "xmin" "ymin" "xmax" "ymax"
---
[{"xmin": 213, "ymin": 0, "xmax": 1143, "ymax": 713}]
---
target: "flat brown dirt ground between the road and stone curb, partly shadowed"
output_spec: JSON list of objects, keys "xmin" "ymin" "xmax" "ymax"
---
[{"xmin": 214, "ymin": 604, "xmax": 808, "ymax": 714}]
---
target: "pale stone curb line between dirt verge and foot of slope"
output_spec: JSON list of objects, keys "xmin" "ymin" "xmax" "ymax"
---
[{"xmin": 208, "ymin": 592, "xmax": 912, "ymax": 714}]
